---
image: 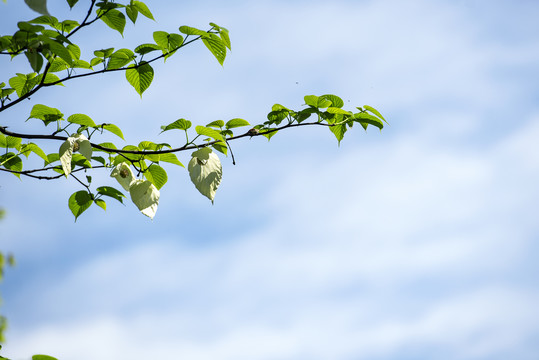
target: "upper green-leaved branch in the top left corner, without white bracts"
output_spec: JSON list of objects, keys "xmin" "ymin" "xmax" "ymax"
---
[{"xmin": 0, "ymin": 0, "xmax": 231, "ymax": 106}]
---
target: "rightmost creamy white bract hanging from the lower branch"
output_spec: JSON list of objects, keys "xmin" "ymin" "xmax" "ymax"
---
[{"xmin": 187, "ymin": 147, "xmax": 223, "ymax": 203}]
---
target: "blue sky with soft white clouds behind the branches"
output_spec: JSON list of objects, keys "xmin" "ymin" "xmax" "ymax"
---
[{"xmin": 0, "ymin": 0, "xmax": 539, "ymax": 360}]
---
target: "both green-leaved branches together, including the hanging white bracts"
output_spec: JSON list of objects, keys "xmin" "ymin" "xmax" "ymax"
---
[{"xmin": 0, "ymin": 0, "xmax": 385, "ymax": 220}]
